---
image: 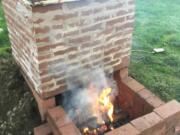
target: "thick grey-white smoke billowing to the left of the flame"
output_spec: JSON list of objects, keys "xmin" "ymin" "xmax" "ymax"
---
[{"xmin": 54, "ymin": 67, "xmax": 117, "ymax": 128}]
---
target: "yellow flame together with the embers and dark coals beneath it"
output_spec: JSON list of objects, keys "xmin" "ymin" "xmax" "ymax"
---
[{"xmin": 79, "ymin": 88, "xmax": 129, "ymax": 135}]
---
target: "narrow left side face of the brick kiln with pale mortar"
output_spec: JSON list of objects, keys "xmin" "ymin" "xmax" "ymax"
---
[{"xmin": 3, "ymin": 0, "xmax": 40, "ymax": 93}]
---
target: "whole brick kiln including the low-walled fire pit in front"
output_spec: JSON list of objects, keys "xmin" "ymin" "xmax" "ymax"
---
[{"xmin": 3, "ymin": 0, "xmax": 180, "ymax": 135}]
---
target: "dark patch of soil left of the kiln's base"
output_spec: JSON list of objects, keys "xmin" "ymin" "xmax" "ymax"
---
[{"xmin": 0, "ymin": 57, "xmax": 40, "ymax": 135}]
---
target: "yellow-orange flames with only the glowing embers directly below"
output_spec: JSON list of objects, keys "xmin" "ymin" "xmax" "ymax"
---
[{"xmin": 82, "ymin": 85, "xmax": 114, "ymax": 135}]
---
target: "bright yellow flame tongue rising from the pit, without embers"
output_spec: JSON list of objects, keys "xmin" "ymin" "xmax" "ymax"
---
[{"xmin": 98, "ymin": 88, "xmax": 114, "ymax": 122}]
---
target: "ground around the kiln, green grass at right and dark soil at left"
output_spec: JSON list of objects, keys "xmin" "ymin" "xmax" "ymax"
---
[{"xmin": 0, "ymin": 0, "xmax": 180, "ymax": 135}]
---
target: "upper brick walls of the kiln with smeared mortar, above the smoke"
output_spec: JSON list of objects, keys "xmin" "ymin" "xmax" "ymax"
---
[{"xmin": 3, "ymin": 0, "xmax": 134, "ymax": 97}]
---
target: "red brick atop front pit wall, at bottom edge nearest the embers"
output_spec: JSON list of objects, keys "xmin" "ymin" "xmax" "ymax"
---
[{"xmin": 105, "ymin": 124, "xmax": 139, "ymax": 135}]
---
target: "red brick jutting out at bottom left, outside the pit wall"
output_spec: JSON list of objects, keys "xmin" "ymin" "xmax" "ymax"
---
[{"xmin": 34, "ymin": 123, "xmax": 52, "ymax": 135}]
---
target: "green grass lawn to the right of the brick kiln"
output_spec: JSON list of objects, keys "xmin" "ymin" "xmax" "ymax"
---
[{"xmin": 130, "ymin": 0, "xmax": 180, "ymax": 101}]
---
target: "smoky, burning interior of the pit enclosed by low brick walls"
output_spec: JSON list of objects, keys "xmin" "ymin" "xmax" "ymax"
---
[{"xmin": 56, "ymin": 70, "xmax": 152, "ymax": 135}]
